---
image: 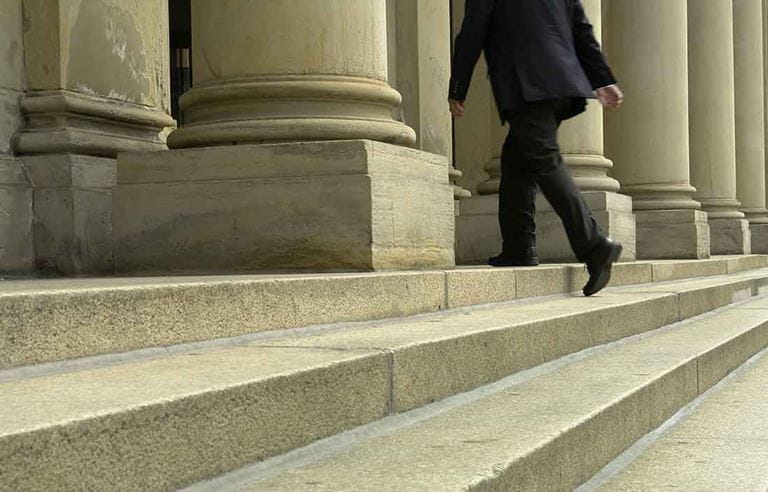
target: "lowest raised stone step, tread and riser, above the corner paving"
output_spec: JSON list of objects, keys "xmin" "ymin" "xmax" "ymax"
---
[{"xmin": 238, "ymin": 296, "xmax": 768, "ymax": 491}]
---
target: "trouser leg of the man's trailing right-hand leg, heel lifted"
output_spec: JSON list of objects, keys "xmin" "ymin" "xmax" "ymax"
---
[{"xmin": 502, "ymin": 101, "xmax": 605, "ymax": 261}]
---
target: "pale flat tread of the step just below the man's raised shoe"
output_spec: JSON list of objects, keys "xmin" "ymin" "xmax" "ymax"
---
[{"xmin": 0, "ymin": 271, "xmax": 768, "ymax": 435}]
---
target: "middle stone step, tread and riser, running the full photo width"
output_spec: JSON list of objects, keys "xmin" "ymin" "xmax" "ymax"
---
[{"xmin": 0, "ymin": 269, "xmax": 768, "ymax": 490}]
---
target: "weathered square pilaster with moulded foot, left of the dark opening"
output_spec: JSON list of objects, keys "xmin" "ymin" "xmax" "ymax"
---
[{"xmin": 13, "ymin": 0, "xmax": 174, "ymax": 157}]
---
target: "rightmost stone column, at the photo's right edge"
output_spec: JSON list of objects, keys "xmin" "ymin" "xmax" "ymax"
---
[{"xmin": 733, "ymin": 0, "xmax": 768, "ymax": 253}]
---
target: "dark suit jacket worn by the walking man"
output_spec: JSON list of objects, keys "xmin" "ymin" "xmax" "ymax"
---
[{"xmin": 449, "ymin": 0, "xmax": 616, "ymax": 120}]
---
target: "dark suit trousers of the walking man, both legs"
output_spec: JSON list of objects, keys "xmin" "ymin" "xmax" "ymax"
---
[{"xmin": 499, "ymin": 99, "xmax": 605, "ymax": 262}]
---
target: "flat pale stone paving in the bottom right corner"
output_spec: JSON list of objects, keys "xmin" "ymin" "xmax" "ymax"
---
[{"xmin": 585, "ymin": 344, "xmax": 768, "ymax": 492}]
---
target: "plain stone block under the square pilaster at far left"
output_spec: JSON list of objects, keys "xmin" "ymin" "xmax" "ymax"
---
[{"xmin": 23, "ymin": 154, "xmax": 115, "ymax": 275}]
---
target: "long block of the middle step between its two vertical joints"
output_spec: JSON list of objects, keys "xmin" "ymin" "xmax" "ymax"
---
[{"xmin": 260, "ymin": 293, "xmax": 679, "ymax": 411}]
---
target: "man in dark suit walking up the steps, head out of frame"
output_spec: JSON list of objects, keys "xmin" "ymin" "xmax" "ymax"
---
[{"xmin": 448, "ymin": 0, "xmax": 623, "ymax": 296}]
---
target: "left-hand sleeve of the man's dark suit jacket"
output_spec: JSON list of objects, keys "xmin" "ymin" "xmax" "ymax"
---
[{"xmin": 448, "ymin": 0, "xmax": 496, "ymax": 101}]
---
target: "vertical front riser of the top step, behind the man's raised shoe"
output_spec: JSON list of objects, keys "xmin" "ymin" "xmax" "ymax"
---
[{"xmin": 0, "ymin": 255, "xmax": 768, "ymax": 369}]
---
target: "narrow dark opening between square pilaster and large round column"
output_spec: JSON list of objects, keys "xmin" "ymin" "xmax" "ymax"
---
[{"xmin": 168, "ymin": 0, "xmax": 192, "ymax": 126}]
